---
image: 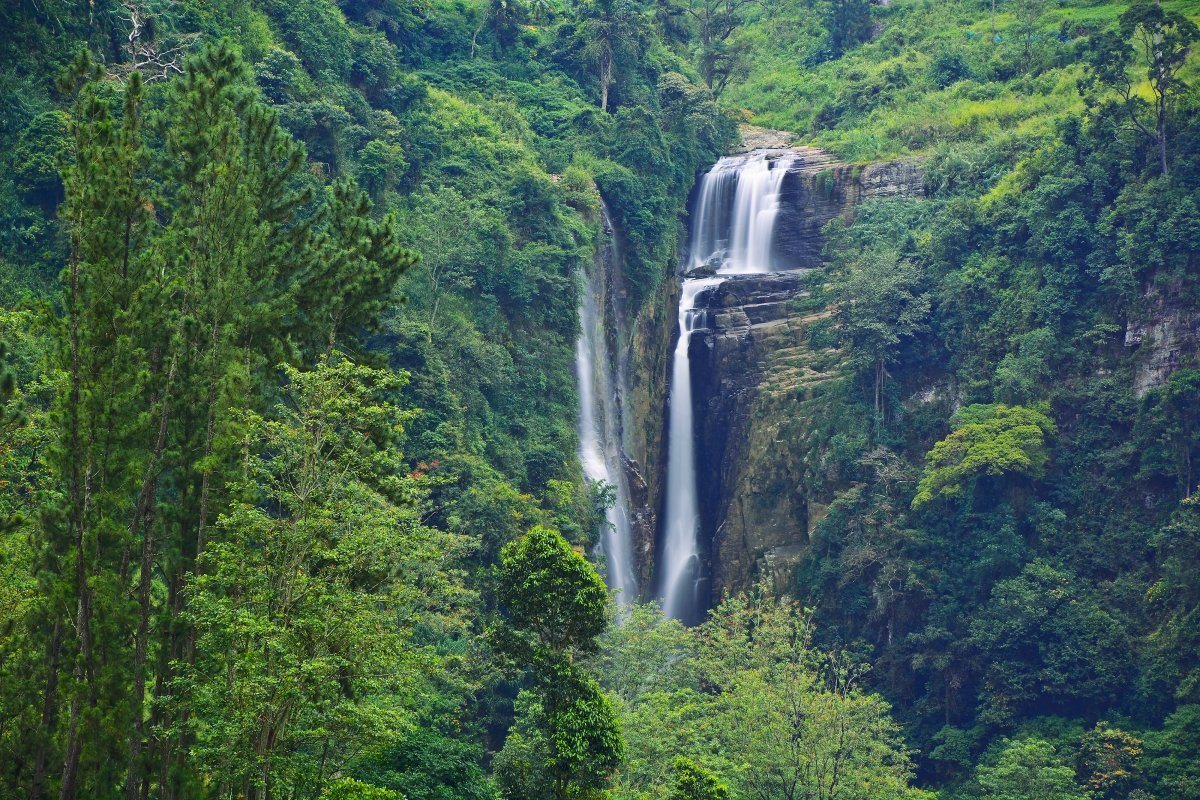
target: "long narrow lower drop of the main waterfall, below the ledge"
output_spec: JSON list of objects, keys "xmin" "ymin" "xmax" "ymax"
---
[{"xmin": 659, "ymin": 278, "xmax": 721, "ymax": 621}]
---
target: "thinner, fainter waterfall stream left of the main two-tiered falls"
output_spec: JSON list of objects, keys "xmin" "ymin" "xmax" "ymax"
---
[{"xmin": 575, "ymin": 210, "xmax": 638, "ymax": 604}]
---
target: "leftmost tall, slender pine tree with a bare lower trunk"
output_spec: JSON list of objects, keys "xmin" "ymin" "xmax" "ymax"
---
[{"xmin": 46, "ymin": 55, "xmax": 151, "ymax": 800}]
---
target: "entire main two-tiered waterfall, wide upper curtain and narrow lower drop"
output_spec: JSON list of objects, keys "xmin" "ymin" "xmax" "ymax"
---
[{"xmin": 658, "ymin": 150, "xmax": 794, "ymax": 624}]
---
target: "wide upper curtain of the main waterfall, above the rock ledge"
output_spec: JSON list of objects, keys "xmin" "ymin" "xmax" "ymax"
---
[{"xmin": 691, "ymin": 150, "xmax": 796, "ymax": 275}]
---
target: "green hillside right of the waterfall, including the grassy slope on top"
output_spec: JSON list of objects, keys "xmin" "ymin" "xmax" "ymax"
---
[{"xmin": 725, "ymin": 1, "xmax": 1200, "ymax": 799}]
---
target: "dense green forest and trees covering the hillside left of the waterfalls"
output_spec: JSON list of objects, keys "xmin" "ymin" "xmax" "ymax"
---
[{"xmin": 0, "ymin": 0, "xmax": 733, "ymax": 800}]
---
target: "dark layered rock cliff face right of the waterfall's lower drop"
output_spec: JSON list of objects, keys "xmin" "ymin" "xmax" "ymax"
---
[{"xmin": 690, "ymin": 270, "xmax": 840, "ymax": 596}]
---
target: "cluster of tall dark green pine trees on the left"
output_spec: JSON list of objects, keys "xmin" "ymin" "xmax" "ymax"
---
[{"xmin": 2, "ymin": 31, "xmax": 452, "ymax": 798}]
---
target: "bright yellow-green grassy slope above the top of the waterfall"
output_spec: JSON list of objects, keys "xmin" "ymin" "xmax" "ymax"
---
[{"xmin": 724, "ymin": 0, "xmax": 1200, "ymax": 161}]
